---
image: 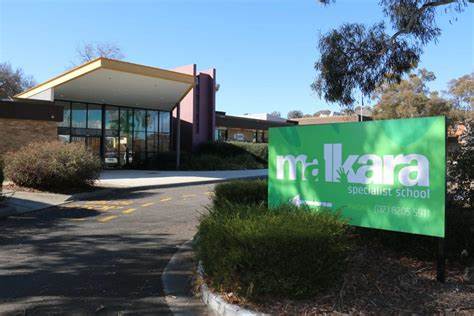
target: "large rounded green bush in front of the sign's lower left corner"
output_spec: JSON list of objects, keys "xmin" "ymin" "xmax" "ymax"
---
[{"xmin": 195, "ymin": 205, "xmax": 350, "ymax": 299}]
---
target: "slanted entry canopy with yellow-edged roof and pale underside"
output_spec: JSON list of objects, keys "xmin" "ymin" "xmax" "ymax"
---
[{"xmin": 16, "ymin": 57, "xmax": 194, "ymax": 111}]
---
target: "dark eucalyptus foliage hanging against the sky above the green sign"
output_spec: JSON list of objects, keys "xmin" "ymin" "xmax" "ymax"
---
[{"xmin": 312, "ymin": 0, "xmax": 474, "ymax": 107}]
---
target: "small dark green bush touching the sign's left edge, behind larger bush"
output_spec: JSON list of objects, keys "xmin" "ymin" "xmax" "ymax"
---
[{"xmin": 213, "ymin": 180, "xmax": 268, "ymax": 206}]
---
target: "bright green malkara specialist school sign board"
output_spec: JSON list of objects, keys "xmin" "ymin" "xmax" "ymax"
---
[{"xmin": 268, "ymin": 117, "xmax": 446, "ymax": 237}]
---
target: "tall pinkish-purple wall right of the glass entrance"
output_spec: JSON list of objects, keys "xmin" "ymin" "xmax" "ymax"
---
[{"xmin": 173, "ymin": 64, "xmax": 216, "ymax": 151}]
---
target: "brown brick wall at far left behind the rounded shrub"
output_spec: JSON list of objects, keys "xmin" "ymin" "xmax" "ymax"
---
[{"xmin": 0, "ymin": 118, "xmax": 58, "ymax": 156}]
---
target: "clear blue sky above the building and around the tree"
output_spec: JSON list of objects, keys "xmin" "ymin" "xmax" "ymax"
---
[{"xmin": 0, "ymin": 0, "xmax": 474, "ymax": 116}]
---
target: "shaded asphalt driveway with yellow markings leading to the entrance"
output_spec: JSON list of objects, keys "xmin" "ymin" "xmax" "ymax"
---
[{"xmin": 0, "ymin": 185, "xmax": 213, "ymax": 315}]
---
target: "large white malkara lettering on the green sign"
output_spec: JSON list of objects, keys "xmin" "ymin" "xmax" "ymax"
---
[{"xmin": 276, "ymin": 144, "xmax": 430, "ymax": 187}]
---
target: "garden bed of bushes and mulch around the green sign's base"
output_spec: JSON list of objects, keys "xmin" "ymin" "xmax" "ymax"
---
[{"xmin": 196, "ymin": 181, "xmax": 474, "ymax": 315}]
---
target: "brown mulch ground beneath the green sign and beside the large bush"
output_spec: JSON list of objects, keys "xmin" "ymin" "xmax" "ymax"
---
[{"xmin": 218, "ymin": 241, "xmax": 474, "ymax": 315}]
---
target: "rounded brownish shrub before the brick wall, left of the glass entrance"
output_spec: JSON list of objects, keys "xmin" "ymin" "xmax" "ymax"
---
[{"xmin": 5, "ymin": 142, "xmax": 101, "ymax": 191}]
